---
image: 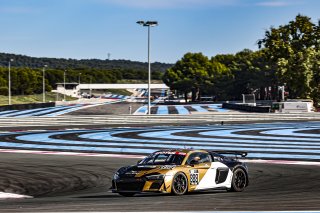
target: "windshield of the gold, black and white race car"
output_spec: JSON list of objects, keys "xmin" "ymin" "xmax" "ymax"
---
[{"xmin": 139, "ymin": 153, "xmax": 186, "ymax": 165}]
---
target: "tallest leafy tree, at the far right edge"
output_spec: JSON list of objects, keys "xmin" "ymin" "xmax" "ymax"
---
[{"xmin": 258, "ymin": 15, "xmax": 320, "ymax": 105}]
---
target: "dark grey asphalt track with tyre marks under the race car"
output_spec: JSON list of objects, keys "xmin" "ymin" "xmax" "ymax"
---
[{"xmin": 0, "ymin": 153, "xmax": 320, "ymax": 212}]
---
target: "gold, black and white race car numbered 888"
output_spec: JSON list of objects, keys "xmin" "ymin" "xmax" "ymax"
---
[{"xmin": 112, "ymin": 149, "xmax": 249, "ymax": 196}]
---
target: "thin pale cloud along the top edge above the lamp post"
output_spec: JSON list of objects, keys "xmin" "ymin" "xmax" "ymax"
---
[{"xmin": 100, "ymin": 0, "xmax": 238, "ymax": 9}]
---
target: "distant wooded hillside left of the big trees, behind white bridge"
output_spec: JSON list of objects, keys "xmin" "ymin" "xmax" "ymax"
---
[{"xmin": 0, "ymin": 53, "xmax": 172, "ymax": 95}]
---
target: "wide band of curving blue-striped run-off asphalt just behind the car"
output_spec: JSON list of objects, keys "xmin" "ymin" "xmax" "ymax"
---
[{"xmin": 0, "ymin": 122, "xmax": 320, "ymax": 161}]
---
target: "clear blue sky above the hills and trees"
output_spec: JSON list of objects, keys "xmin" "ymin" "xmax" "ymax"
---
[{"xmin": 0, "ymin": 0, "xmax": 320, "ymax": 63}]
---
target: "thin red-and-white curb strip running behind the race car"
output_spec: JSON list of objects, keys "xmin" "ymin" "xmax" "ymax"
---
[{"xmin": 0, "ymin": 149, "xmax": 320, "ymax": 166}]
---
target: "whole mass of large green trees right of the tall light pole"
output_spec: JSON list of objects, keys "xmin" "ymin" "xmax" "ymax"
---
[{"xmin": 163, "ymin": 14, "xmax": 320, "ymax": 105}]
